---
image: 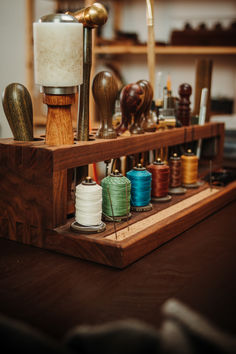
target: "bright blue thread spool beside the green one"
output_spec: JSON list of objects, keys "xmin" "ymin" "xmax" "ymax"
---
[{"xmin": 126, "ymin": 164, "xmax": 152, "ymax": 211}]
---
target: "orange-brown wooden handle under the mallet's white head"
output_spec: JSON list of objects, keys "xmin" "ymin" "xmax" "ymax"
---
[{"xmin": 43, "ymin": 94, "xmax": 75, "ymax": 145}]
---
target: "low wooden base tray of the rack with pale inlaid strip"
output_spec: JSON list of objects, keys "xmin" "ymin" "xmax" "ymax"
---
[{"xmin": 0, "ymin": 181, "xmax": 236, "ymax": 268}]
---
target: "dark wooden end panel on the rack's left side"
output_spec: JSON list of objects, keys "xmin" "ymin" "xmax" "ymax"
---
[{"xmin": 0, "ymin": 145, "xmax": 53, "ymax": 243}]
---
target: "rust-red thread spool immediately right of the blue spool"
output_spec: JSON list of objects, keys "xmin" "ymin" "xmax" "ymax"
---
[{"xmin": 147, "ymin": 158, "xmax": 171, "ymax": 202}]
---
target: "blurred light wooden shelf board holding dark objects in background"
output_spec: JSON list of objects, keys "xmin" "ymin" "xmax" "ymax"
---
[{"xmin": 94, "ymin": 45, "xmax": 236, "ymax": 55}]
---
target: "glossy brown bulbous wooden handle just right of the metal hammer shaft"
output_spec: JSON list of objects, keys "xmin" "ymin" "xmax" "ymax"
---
[{"xmin": 92, "ymin": 71, "xmax": 118, "ymax": 139}]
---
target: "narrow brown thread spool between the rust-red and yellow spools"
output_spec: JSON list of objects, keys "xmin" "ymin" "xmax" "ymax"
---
[{"xmin": 169, "ymin": 153, "xmax": 187, "ymax": 194}]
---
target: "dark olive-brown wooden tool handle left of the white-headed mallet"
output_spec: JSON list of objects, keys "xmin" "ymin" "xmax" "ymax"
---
[{"xmin": 2, "ymin": 83, "xmax": 34, "ymax": 141}]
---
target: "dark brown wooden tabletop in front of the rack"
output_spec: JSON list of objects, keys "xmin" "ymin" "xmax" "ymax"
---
[{"xmin": 0, "ymin": 201, "xmax": 236, "ymax": 338}]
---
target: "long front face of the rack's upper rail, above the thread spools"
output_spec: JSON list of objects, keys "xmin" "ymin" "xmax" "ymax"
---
[{"xmin": 51, "ymin": 123, "xmax": 224, "ymax": 170}]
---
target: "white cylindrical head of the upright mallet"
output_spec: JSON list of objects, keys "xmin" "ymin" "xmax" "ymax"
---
[{"xmin": 33, "ymin": 15, "xmax": 83, "ymax": 87}]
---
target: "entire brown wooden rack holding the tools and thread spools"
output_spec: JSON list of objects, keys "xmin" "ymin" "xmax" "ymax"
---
[{"xmin": 0, "ymin": 123, "xmax": 236, "ymax": 268}]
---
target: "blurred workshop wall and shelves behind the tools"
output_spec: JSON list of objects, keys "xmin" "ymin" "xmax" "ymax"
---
[{"xmin": 0, "ymin": 0, "xmax": 236, "ymax": 166}]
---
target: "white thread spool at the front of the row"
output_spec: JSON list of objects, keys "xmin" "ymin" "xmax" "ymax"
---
[{"xmin": 71, "ymin": 177, "xmax": 106, "ymax": 233}]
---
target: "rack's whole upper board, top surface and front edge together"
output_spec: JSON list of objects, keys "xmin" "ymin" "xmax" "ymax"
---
[{"xmin": 0, "ymin": 123, "xmax": 224, "ymax": 171}]
